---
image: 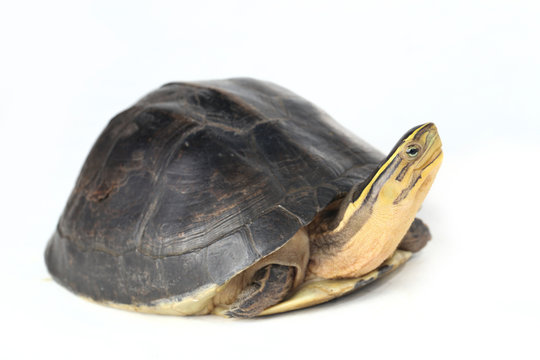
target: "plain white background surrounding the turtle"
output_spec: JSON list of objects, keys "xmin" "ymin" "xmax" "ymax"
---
[{"xmin": 0, "ymin": 0, "xmax": 540, "ymax": 359}]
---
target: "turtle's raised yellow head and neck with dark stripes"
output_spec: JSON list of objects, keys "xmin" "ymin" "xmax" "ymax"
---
[{"xmin": 309, "ymin": 124, "xmax": 442, "ymax": 278}]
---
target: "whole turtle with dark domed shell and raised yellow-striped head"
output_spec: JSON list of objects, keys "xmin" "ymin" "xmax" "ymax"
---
[{"xmin": 45, "ymin": 78, "xmax": 442, "ymax": 318}]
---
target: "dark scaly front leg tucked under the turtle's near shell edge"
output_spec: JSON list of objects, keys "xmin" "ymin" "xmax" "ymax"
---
[{"xmin": 225, "ymin": 264, "xmax": 296, "ymax": 318}]
